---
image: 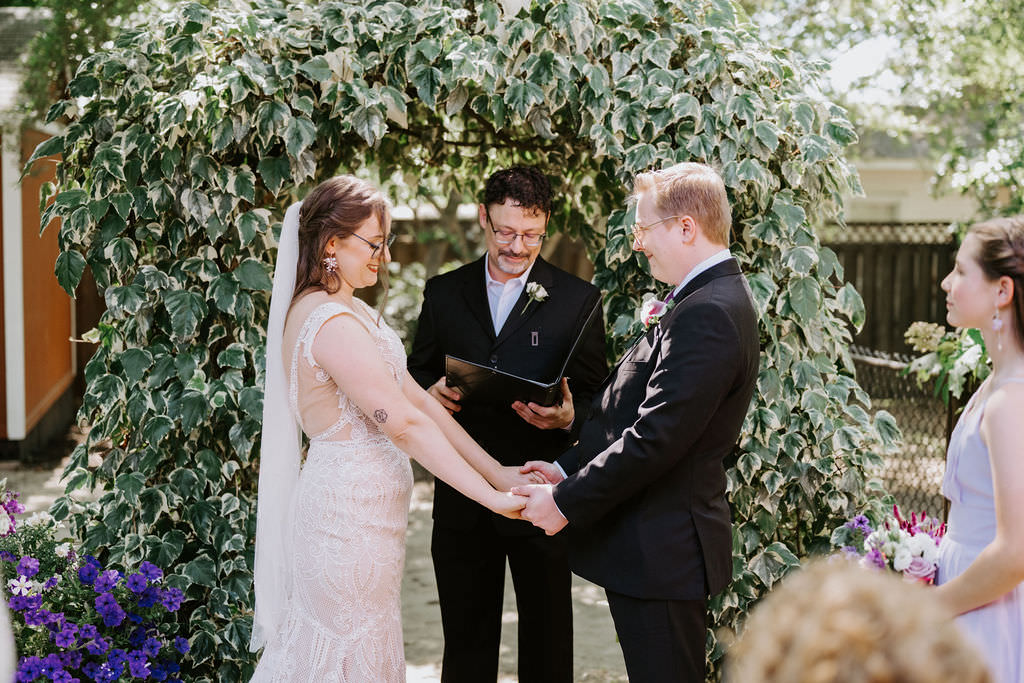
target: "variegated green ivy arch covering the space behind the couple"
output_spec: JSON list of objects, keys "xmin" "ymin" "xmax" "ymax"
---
[{"xmin": 37, "ymin": 0, "xmax": 898, "ymax": 681}]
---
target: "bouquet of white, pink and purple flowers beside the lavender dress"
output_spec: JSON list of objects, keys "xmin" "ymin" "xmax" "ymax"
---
[{"xmin": 831, "ymin": 505, "xmax": 946, "ymax": 584}]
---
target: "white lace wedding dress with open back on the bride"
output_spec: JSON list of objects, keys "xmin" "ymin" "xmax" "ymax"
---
[{"xmin": 252, "ymin": 299, "xmax": 413, "ymax": 683}]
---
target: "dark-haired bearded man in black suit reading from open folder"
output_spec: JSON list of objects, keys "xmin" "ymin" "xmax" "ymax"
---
[{"xmin": 409, "ymin": 167, "xmax": 607, "ymax": 683}]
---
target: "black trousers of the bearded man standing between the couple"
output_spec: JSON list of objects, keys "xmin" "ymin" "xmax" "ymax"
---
[{"xmin": 430, "ymin": 522, "xmax": 572, "ymax": 683}]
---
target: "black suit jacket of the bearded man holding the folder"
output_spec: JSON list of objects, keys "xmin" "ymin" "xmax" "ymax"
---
[{"xmin": 408, "ymin": 257, "xmax": 607, "ymax": 535}]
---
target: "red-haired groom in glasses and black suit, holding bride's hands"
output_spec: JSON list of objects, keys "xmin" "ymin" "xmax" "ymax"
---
[{"xmin": 513, "ymin": 163, "xmax": 759, "ymax": 683}]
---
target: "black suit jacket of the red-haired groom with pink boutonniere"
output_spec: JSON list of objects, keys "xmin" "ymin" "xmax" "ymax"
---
[{"xmin": 554, "ymin": 259, "xmax": 759, "ymax": 600}]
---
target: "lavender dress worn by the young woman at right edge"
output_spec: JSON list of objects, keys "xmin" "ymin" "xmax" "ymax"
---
[{"xmin": 937, "ymin": 378, "xmax": 1024, "ymax": 683}]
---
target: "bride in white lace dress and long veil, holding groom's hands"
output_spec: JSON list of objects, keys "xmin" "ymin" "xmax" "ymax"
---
[{"xmin": 250, "ymin": 176, "xmax": 525, "ymax": 683}]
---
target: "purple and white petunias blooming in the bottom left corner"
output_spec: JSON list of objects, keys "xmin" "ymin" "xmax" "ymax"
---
[{"xmin": 0, "ymin": 482, "xmax": 189, "ymax": 683}]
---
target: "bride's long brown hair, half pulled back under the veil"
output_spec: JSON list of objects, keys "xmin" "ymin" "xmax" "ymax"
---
[{"xmin": 294, "ymin": 175, "xmax": 391, "ymax": 297}]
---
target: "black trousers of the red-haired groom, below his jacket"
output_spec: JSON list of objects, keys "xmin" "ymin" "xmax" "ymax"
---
[{"xmin": 605, "ymin": 590, "xmax": 708, "ymax": 683}]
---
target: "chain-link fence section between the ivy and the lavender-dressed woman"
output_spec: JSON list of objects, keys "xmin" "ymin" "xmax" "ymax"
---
[{"xmin": 850, "ymin": 346, "xmax": 955, "ymax": 518}]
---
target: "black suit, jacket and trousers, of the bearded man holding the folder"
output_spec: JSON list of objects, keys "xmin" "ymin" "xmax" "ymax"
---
[{"xmin": 409, "ymin": 257, "xmax": 607, "ymax": 683}]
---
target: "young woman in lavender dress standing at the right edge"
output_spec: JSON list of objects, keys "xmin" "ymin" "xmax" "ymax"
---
[{"xmin": 936, "ymin": 216, "xmax": 1024, "ymax": 683}]
